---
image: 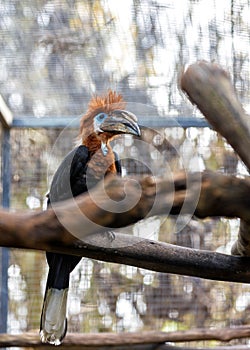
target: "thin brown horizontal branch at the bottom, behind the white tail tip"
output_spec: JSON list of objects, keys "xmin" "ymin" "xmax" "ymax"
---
[{"xmin": 0, "ymin": 326, "xmax": 250, "ymax": 349}]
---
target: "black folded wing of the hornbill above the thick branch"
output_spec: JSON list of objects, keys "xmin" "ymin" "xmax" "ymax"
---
[{"xmin": 48, "ymin": 145, "xmax": 90, "ymax": 204}]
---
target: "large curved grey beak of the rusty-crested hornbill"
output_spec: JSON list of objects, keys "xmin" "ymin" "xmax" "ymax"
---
[{"xmin": 100, "ymin": 109, "xmax": 141, "ymax": 136}]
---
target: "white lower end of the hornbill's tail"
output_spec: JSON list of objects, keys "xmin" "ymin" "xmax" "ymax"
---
[{"xmin": 40, "ymin": 288, "xmax": 68, "ymax": 345}]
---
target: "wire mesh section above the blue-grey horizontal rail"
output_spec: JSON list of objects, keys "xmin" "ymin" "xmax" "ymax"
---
[{"xmin": 0, "ymin": 0, "xmax": 249, "ymax": 118}]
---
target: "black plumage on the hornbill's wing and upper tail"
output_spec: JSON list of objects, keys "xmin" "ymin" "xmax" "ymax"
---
[{"xmin": 40, "ymin": 145, "xmax": 121, "ymax": 341}]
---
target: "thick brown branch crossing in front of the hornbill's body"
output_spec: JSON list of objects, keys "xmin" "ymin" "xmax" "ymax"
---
[{"xmin": 0, "ymin": 172, "xmax": 250, "ymax": 254}]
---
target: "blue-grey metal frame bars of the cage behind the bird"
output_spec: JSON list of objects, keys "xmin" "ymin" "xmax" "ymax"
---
[{"xmin": 0, "ymin": 96, "xmax": 210, "ymax": 333}]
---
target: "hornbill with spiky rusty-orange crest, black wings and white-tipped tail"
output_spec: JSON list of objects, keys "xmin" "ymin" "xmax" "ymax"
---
[{"xmin": 40, "ymin": 90, "xmax": 141, "ymax": 345}]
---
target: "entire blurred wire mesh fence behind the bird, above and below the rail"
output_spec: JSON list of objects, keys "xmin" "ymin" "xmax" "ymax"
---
[{"xmin": 0, "ymin": 0, "xmax": 250, "ymax": 345}]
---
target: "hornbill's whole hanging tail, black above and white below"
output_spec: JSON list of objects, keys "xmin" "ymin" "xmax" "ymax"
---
[{"xmin": 40, "ymin": 253, "xmax": 81, "ymax": 345}]
